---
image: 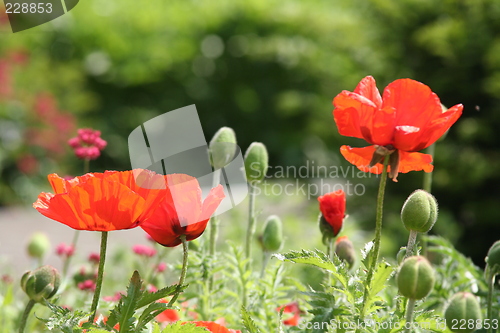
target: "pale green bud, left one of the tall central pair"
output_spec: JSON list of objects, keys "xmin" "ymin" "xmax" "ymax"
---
[{"xmin": 209, "ymin": 127, "xmax": 237, "ymax": 169}]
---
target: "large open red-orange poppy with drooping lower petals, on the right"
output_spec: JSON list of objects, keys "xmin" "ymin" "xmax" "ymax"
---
[{"xmin": 333, "ymin": 76, "xmax": 463, "ymax": 181}]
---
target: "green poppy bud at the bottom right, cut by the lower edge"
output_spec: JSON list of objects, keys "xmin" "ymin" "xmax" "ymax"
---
[{"xmin": 444, "ymin": 292, "xmax": 482, "ymax": 332}]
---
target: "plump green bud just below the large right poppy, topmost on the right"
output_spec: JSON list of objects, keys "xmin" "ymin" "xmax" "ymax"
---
[{"xmin": 401, "ymin": 190, "xmax": 438, "ymax": 232}]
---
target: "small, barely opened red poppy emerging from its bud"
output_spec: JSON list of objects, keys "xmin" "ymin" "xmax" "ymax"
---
[{"xmin": 318, "ymin": 190, "xmax": 345, "ymax": 237}]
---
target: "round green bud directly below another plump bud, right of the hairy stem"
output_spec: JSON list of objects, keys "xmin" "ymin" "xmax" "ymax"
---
[{"xmin": 396, "ymin": 256, "xmax": 435, "ymax": 300}]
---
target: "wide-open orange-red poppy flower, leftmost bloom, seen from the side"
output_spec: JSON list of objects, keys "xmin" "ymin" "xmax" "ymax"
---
[{"xmin": 33, "ymin": 170, "xmax": 167, "ymax": 231}]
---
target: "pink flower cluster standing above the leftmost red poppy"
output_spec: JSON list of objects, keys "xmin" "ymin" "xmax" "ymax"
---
[{"xmin": 68, "ymin": 128, "xmax": 108, "ymax": 160}]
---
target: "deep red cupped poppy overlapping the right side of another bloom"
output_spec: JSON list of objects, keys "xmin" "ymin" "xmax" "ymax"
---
[{"xmin": 141, "ymin": 174, "xmax": 224, "ymax": 247}]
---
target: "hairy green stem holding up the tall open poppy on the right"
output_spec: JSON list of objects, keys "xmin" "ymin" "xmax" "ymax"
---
[{"xmin": 361, "ymin": 156, "xmax": 389, "ymax": 320}]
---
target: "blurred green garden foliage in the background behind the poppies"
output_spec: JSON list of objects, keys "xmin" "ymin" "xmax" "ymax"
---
[{"xmin": 0, "ymin": 0, "xmax": 500, "ymax": 265}]
